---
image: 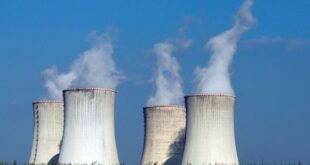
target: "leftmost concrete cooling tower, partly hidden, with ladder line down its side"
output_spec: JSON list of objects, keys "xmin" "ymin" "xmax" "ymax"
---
[{"xmin": 29, "ymin": 101, "xmax": 64, "ymax": 164}]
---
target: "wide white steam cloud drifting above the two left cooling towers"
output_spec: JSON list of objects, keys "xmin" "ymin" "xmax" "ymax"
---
[{"xmin": 43, "ymin": 34, "xmax": 122, "ymax": 99}]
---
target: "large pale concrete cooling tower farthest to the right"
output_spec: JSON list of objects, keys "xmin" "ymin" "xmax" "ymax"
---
[{"xmin": 182, "ymin": 95, "xmax": 239, "ymax": 165}]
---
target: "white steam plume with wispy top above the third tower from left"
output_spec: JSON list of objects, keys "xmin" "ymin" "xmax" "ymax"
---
[{"xmin": 147, "ymin": 20, "xmax": 197, "ymax": 106}]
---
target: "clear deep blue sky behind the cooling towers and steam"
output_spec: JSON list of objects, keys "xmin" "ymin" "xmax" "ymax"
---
[{"xmin": 0, "ymin": 0, "xmax": 310, "ymax": 165}]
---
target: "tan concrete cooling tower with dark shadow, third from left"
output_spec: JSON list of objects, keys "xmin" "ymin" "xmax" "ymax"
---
[{"xmin": 141, "ymin": 106, "xmax": 186, "ymax": 165}]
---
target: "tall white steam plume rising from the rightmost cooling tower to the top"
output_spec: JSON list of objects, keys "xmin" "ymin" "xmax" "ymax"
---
[{"xmin": 195, "ymin": 0, "xmax": 256, "ymax": 95}]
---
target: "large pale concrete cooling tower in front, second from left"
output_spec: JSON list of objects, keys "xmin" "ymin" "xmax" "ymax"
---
[{"xmin": 59, "ymin": 88, "xmax": 119, "ymax": 165}]
